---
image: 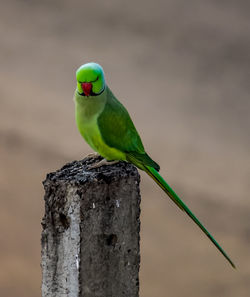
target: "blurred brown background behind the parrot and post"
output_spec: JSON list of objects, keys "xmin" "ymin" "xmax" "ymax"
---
[{"xmin": 0, "ymin": 0, "xmax": 250, "ymax": 297}]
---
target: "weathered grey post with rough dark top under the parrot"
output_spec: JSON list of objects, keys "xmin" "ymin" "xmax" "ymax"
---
[{"xmin": 41, "ymin": 159, "xmax": 140, "ymax": 297}]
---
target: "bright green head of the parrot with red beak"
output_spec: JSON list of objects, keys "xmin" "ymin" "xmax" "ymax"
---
[{"xmin": 76, "ymin": 63, "xmax": 105, "ymax": 97}]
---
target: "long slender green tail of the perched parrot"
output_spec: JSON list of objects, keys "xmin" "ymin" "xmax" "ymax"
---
[{"xmin": 143, "ymin": 165, "xmax": 236, "ymax": 268}]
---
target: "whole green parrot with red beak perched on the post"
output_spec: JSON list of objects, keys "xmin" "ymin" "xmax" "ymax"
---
[{"xmin": 74, "ymin": 63, "xmax": 235, "ymax": 268}]
